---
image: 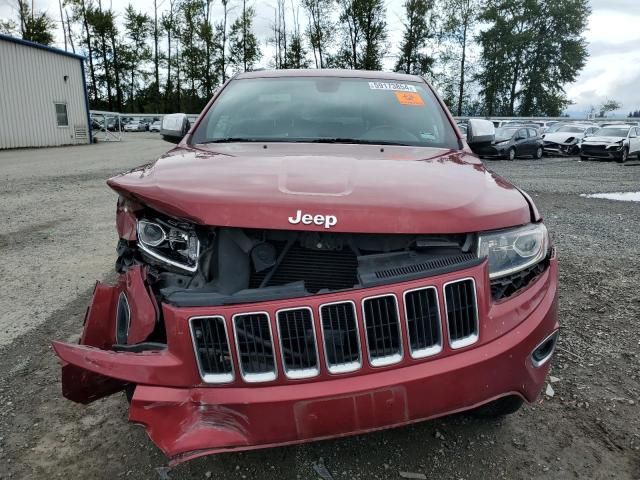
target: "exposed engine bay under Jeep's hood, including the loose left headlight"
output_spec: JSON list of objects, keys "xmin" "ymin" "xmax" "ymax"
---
[{"xmin": 116, "ymin": 210, "xmax": 480, "ymax": 306}]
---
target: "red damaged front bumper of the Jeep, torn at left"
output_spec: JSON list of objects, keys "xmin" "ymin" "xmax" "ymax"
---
[{"xmin": 53, "ymin": 258, "xmax": 558, "ymax": 464}]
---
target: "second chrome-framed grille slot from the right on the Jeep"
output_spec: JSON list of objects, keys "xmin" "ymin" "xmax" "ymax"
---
[{"xmin": 404, "ymin": 287, "xmax": 442, "ymax": 358}]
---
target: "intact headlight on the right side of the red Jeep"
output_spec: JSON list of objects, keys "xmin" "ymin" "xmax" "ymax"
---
[{"xmin": 478, "ymin": 223, "xmax": 549, "ymax": 279}]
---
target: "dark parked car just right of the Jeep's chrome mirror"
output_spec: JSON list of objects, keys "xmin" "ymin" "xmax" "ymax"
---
[{"xmin": 476, "ymin": 125, "xmax": 542, "ymax": 160}]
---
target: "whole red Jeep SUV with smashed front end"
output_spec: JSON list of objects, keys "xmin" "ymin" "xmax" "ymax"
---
[{"xmin": 53, "ymin": 70, "xmax": 558, "ymax": 464}]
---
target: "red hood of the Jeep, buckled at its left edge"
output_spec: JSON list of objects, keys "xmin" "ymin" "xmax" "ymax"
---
[{"xmin": 108, "ymin": 143, "xmax": 531, "ymax": 233}]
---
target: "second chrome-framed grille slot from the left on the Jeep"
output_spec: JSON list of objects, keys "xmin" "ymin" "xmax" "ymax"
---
[{"xmin": 233, "ymin": 312, "xmax": 276, "ymax": 382}]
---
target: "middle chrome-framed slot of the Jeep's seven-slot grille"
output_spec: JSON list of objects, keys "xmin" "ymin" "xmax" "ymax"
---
[{"xmin": 320, "ymin": 301, "xmax": 362, "ymax": 373}]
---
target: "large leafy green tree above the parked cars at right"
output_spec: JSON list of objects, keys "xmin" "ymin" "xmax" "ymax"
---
[{"xmin": 478, "ymin": 0, "xmax": 590, "ymax": 116}]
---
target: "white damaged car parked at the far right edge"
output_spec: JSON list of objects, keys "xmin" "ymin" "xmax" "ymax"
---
[{"xmin": 580, "ymin": 125, "xmax": 640, "ymax": 163}]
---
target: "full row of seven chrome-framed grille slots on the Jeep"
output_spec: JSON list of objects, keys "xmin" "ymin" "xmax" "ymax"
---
[{"xmin": 190, "ymin": 278, "xmax": 479, "ymax": 383}]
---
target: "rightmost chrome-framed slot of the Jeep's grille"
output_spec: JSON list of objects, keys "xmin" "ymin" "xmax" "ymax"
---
[{"xmin": 444, "ymin": 278, "xmax": 478, "ymax": 348}]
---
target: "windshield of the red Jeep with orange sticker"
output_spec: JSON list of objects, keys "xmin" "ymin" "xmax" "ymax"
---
[{"xmin": 191, "ymin": 77, "xmax": 458, "ymax": 149}]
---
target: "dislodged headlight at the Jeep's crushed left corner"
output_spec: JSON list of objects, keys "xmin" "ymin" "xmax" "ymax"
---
[{"xmin": 137, "ymin": 218, "xmax": 200, "ymax": 272}]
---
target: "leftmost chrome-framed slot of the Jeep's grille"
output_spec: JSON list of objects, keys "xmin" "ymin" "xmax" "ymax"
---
[{"xmin": 189, "ymin": 316, "xmax": 234, "ymax": 383}]
